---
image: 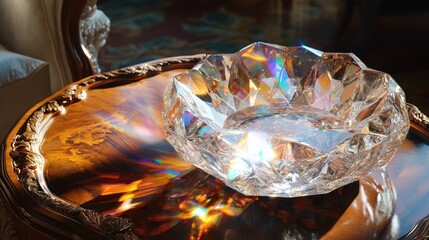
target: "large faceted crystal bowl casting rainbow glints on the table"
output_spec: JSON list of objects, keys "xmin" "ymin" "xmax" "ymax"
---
[{"xmin": 163, "ymin": 42, "xmax": 409, "ymax": 197}]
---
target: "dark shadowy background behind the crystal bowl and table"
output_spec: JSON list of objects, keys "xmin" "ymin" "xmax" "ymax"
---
[{"xmin": 98, "ymin": 0, "xmax": 429, "ymax": 113}]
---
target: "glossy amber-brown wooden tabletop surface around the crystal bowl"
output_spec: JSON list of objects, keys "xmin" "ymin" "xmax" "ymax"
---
[{"xmin": 3, "ymin": 64, "xmax": 429, "ymax": 239}]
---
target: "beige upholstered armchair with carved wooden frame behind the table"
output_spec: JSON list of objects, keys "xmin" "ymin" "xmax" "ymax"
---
[{"xmin": 0, "ymin": 0, "xmax": 110, "ymax": 141}]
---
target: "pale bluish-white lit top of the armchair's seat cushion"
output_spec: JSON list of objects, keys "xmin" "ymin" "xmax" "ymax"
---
[{"xmin": 0, "ymin": 45, "xmax": 46, "ymax": 87}]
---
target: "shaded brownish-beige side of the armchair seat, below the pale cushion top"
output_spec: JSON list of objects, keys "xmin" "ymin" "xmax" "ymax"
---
[{"xmin": 0, "ymin": 63, "xmax": 50, "ymax": 141}]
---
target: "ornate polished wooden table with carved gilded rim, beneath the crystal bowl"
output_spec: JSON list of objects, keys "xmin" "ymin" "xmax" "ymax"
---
[{"xmin": 0, "ymin": 55, "xmax": 429, "ymax": 239}]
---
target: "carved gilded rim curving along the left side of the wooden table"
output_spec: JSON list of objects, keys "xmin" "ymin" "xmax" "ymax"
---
[{"xmin": 10, "ymin": 55, "xmax": 205, "ymax": 239}]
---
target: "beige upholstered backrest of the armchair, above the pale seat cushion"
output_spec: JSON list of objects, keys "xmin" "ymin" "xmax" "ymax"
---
[{"xmin": 0, "ymin": 0, "xmax": 72, "ymax": 91}]
